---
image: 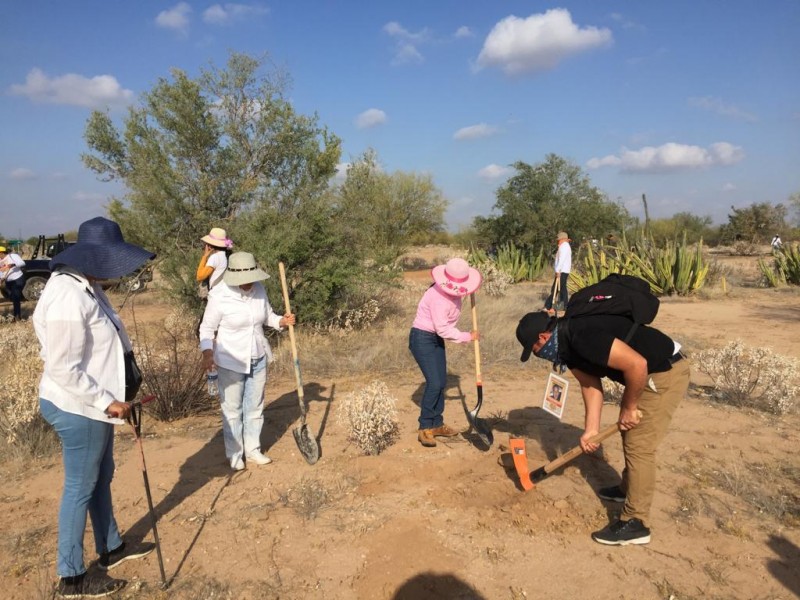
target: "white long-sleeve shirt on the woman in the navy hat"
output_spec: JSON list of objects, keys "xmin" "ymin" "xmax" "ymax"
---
[{"xmin": 33, "ymin": 267, "xmax": 131, "ymax": 425}]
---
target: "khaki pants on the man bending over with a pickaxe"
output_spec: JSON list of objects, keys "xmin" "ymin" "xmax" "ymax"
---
[{"xmin": 621, "ymin": 359, "xmax": 689, "ymax": 525}]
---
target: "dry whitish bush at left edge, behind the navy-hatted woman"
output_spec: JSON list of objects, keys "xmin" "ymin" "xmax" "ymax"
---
[{"xmin": 0, "ymin": 320, "xmax": 59, "ymax": 458}]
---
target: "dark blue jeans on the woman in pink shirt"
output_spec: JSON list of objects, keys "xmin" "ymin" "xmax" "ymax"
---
[{"xmin": 408, "ymin": 327, "xmax": 447, "ymax": 429}]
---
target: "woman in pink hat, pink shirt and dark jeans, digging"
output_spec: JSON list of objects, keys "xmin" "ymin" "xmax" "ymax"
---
[{"xmin": 408, "ymin": 258, "xmax": 481, "ymax": 447}]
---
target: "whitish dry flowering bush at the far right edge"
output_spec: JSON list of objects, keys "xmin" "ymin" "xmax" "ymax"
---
[{"xmin": 696, "ymin": 340, "xmax": 800, "ymax": 415}]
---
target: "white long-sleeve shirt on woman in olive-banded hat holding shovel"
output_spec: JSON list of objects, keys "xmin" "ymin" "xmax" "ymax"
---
[{"xmin": 200, "ymin": 282, "xmax": 282, "ymax": 373}]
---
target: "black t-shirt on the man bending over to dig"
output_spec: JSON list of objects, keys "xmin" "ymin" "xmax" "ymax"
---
[{"xmin": 558, "ymin": 315, "xmax": 675, "ymax": 383}]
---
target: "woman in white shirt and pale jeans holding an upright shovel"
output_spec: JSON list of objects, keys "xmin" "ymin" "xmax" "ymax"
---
[{"xmin": 200, "ymin": 252, "xmax": 295, "ymax": 471}]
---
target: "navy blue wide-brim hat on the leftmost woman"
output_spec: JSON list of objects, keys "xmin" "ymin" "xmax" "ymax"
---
[{"xmin": 50, "ymin": 217, "xmax": 155, "ymax": 279}]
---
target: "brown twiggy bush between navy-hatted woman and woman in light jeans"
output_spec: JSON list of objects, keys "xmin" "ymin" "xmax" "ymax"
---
[{"xmin": 134, "ymin": 310, "xmax": 216, "ymax": 421}]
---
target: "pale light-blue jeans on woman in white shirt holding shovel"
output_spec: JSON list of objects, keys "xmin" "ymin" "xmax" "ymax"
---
[{"xmin": 217, "ymin": 356, "xmax": 267, "ymax": 465}]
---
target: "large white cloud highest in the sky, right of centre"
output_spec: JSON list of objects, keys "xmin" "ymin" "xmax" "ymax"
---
[{"xmin": 477, "ymin": 8, "xmax": 613, "ymax": 75}]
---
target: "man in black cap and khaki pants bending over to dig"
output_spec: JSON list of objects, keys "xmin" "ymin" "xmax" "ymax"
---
[{"xmin": 517, "ymin": 312, "xmax": 689, "ymax": 545}]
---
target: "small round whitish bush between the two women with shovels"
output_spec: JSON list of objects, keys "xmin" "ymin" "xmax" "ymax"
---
[{"xmin": 338, "ymin": 381, "xmax": 399, "ymax": 456}]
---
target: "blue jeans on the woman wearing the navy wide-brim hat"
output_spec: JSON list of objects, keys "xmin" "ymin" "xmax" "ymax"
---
[{"xmin": 39, "ymin": 398, "xmax": 122, "ymax": 577}]
